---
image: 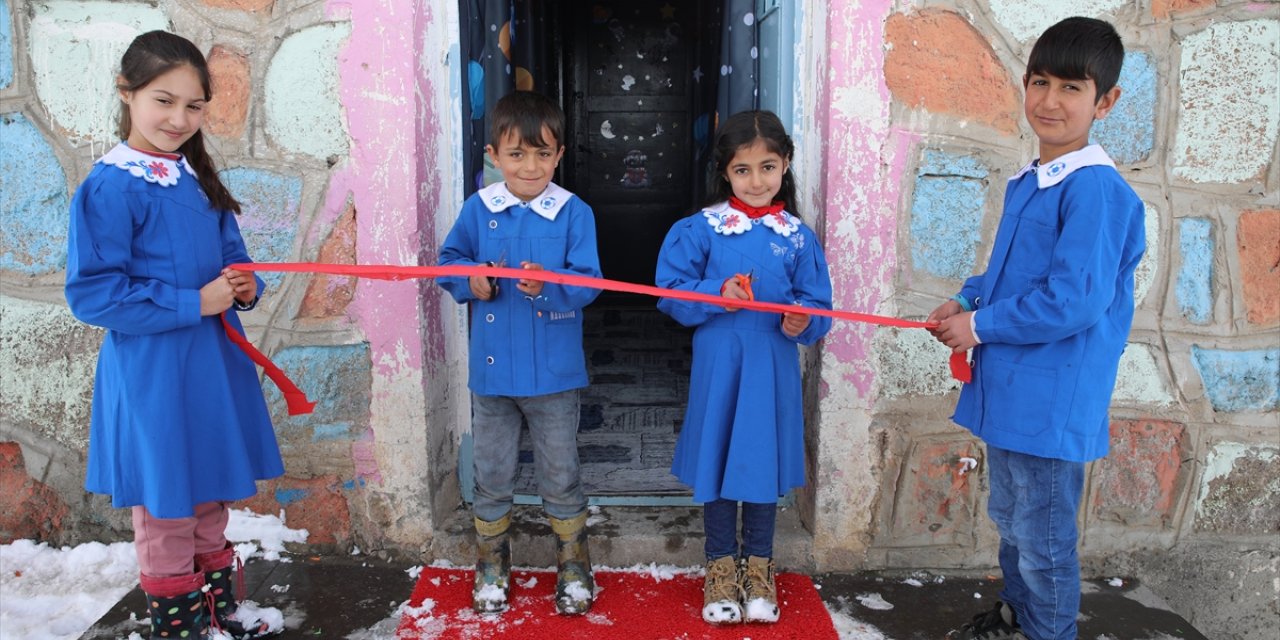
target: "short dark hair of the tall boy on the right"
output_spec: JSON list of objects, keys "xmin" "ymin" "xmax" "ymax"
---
[{"xmin": 1027, "ymin": 17, "xmax": 1124, "ymax": 101}]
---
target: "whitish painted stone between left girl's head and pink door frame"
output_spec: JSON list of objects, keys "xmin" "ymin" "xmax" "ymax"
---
[{"xmin": 264, "ymin": 22, "xmax": 351, "ymax": 159}]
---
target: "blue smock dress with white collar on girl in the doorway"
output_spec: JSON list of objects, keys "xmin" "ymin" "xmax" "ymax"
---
[{"xmin": 657, "ymin": 202, "xmax": 831, "ymax": 503}]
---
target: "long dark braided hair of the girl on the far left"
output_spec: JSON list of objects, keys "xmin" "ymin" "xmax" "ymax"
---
[{"xmin": 116, "ymin": 31, "xmax": 241, "ymax": 214}]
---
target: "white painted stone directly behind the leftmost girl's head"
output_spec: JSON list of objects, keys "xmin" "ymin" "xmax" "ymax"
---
[{"xmin": 27, "ymin": 1, "xmax": 169, "ymax": 145}]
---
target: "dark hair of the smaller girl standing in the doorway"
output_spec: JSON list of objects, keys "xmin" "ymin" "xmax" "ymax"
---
[{"xmin": 707, "ymin": 111, "xmax": 800, "ymax": 216}]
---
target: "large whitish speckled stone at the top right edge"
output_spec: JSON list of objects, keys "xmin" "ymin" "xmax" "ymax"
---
[{"xmin": 1174, "ymin": 20, "xmax": 1280, "ymax": 183}]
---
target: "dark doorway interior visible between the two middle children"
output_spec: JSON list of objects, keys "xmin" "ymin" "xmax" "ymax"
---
[{"xmin": 504, "ymin": 1, "xmax": 718, "ymax": 504}]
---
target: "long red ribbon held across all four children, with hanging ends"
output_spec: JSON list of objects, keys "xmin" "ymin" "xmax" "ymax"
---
[{"xmin": 230, "ymin": 262, "xmax": 973, "ymax": 415}]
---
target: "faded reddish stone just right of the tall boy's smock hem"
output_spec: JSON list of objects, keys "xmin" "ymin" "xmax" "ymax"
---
[{"xmin": 1093, "ymin": 420, "xmax": 1187, "ymax": 527}]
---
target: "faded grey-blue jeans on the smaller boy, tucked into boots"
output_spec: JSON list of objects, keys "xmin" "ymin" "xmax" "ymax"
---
[{"xmin": 471, "ymin": 389, "xmax": 586, "ymax": 522}]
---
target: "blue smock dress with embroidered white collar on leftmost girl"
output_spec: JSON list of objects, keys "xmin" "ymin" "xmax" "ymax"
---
[{"xmin": 65, "ymin": 143, "xmax": 284, "ymax": 518}]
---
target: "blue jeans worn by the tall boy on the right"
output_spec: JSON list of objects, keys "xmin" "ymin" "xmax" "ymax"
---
[{"xmin": 987, "ymin": 445, "xmax": 1084, "ymax": 640}]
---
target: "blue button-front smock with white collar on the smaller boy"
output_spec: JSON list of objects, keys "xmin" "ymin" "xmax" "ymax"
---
[{"xmin": 436, "ymin": 182, "xmax": 600, "ymax": 397}]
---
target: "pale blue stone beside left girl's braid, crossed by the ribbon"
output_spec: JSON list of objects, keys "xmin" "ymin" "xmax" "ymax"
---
[{"xmin": 219, "ymin": 168, "xmax": 302, "ymax": 289}]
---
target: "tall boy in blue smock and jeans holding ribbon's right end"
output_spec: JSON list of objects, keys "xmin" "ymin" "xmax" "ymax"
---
[{"xmin": 929, "ymin": 18, "xmax": 1146, "ymax": 640}]
